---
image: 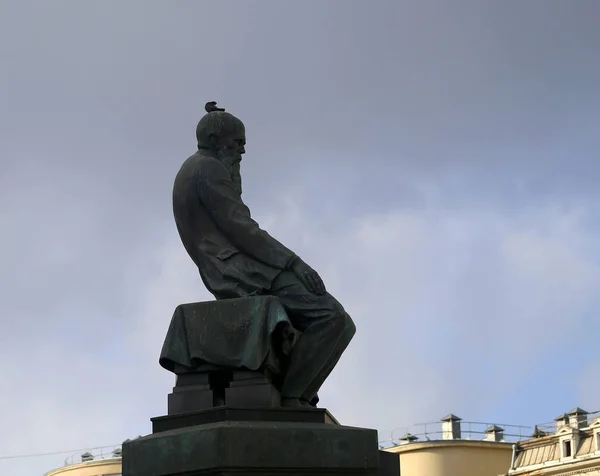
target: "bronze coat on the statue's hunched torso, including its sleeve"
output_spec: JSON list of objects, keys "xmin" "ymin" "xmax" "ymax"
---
[{"xmin": 173, "ymin": 151, "xmax": 296, "ymax": 299}]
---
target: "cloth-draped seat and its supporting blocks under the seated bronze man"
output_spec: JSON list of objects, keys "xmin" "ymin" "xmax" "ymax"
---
[{"xmin": 159, "ymin": 296, "xmax": 297, "ymax": 415}]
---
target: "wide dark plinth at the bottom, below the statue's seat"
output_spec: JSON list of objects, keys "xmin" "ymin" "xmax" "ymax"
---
[{"xmin": 123, "ymin": 421, "xmax": 400, "ymax": 476}]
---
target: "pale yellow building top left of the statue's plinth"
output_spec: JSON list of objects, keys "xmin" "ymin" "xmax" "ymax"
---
[{"xmin": 45, "ymin": 447, "xmax": 122, "ymax": 476}]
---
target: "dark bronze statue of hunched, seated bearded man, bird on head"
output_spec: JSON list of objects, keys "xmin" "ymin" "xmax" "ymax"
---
[{"xmin": 173, "ymin": 102, "xmax": 356, "ymax": 406}]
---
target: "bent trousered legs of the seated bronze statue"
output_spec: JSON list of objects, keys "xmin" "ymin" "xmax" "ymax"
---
[{"xmin": 269, "ymin": 271, "xmax": 356, "ymax": 402}]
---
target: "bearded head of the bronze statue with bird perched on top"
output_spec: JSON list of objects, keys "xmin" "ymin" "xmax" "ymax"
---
[{"xmin": 196, "ymin": 102, "xmax": 246, "ymax": 162}]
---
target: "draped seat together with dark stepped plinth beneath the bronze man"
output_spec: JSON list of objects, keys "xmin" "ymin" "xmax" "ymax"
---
[{"xmin": 127, "ymin": 296, "xmax": 400, "ymax": 476}]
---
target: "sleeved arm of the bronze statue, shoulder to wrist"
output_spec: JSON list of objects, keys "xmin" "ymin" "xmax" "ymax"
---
[{"xmin": 198, "ymin": 160, "xmax": 296, "ymax": 269}]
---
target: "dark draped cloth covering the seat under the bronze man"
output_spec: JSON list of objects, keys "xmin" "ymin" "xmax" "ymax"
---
[{"xmin": 159, "ymin": 296, "xmax": 297, "ymax": 375}]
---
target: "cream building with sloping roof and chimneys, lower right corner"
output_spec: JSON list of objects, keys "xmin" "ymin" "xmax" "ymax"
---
[{"xmin": 504, "ymin": 408, "xmax": 600, "ymax": 476}]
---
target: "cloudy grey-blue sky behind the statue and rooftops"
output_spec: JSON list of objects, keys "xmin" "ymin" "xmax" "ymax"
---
[{"xmin": 0, "ymin": 0, "xmax": 600, "ymax": 476}]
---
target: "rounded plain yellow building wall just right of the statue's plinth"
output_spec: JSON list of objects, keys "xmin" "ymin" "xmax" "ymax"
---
[{"xmin": 389, "ymin": 440, "xmax": 512, "ymax": 476}]
